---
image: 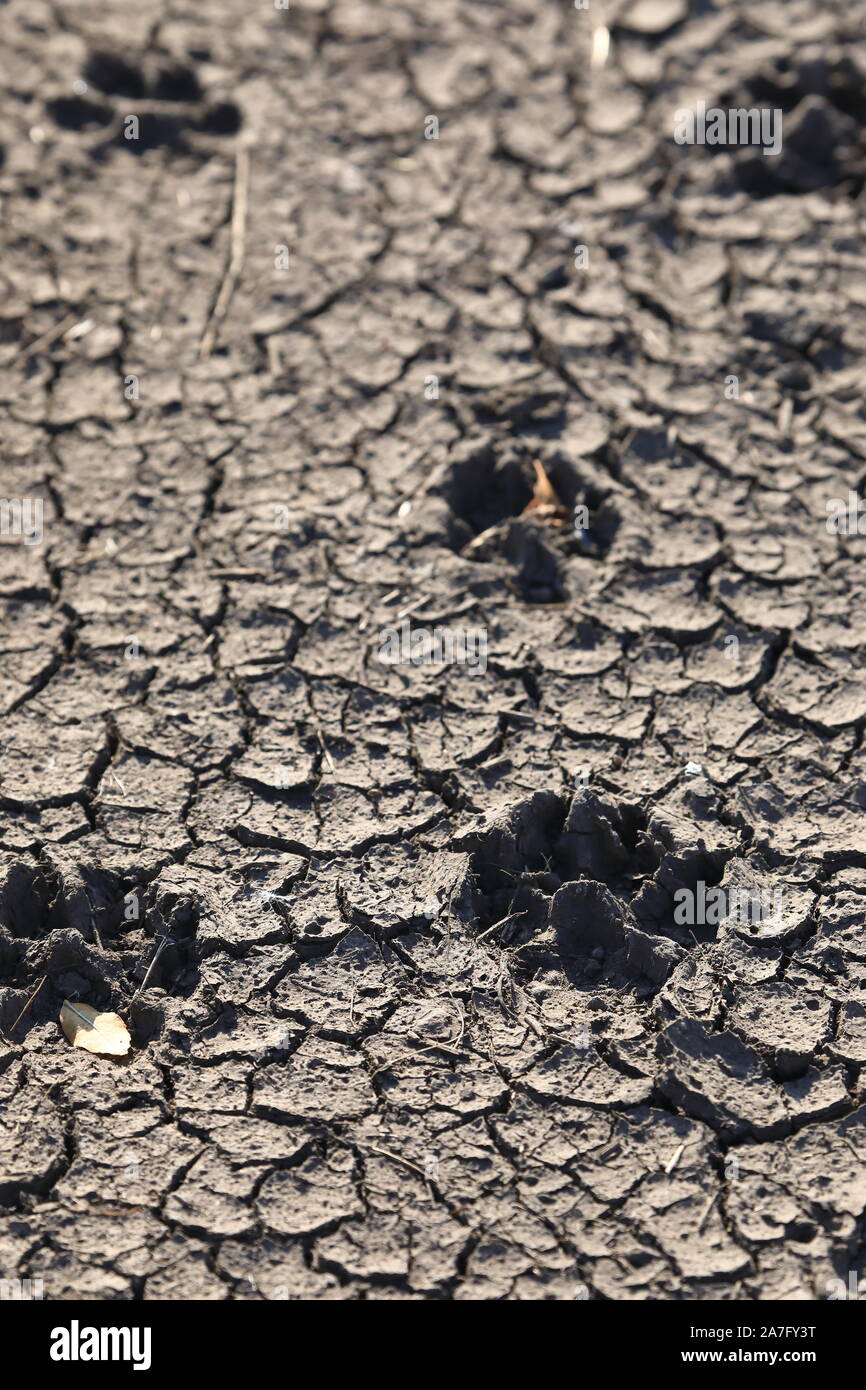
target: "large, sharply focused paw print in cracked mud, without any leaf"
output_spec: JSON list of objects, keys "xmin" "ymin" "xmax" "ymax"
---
[{"xmin": 460, "ymin": 777, "xmax": 809, "ymax": 995}]
